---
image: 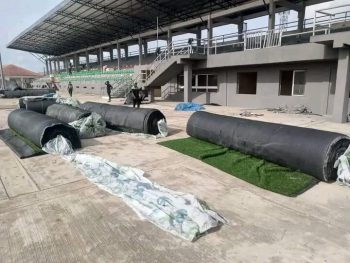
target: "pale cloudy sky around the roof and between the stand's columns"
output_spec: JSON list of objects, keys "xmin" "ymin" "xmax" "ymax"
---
[{"xmin": 0, "ymin": 0, "xmax": 344, "ymax": 72}]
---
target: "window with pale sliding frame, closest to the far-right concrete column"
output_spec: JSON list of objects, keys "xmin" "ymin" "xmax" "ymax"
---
[{"xmin": 280, "ymin": 70, "xmax": 306, "ymax": 96}]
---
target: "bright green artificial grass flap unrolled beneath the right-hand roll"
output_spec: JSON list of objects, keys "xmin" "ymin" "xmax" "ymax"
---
[{"xmin": 159, "ymin": 137, "xmax": 318, "ymax": 196}]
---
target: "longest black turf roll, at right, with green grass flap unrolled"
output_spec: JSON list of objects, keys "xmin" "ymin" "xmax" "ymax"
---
[{"xmin": 187, "ymin": 111, "xmax": 350, "ymax": 181}]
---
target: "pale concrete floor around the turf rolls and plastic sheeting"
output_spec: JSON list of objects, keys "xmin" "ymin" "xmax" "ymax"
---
[{"xmin": 0, "ymin": 95, "xmax": 350, "ymax": 263}]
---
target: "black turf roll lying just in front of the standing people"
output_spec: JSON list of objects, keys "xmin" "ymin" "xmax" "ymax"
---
[{"xmin": 79, "ymin": 102, "xmax": 165, "ymax": 135}]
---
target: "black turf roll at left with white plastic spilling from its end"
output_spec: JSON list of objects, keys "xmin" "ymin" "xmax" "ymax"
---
[{"xmin": 8, "ymin": 109, "xmax": 81, "ymax": 148}]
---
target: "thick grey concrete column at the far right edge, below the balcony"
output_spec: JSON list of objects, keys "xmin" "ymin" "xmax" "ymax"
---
[{"xmin": 333, "ymin": 48, "xmax": 350, "ymax": 122}]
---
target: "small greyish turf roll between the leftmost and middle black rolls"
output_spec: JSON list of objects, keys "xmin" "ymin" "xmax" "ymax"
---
[{"xmin": 46, "ymin": 104, "xmax": 91, "ymax": 123}]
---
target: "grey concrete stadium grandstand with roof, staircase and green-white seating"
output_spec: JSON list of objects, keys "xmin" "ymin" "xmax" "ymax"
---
[{"xmin": 8, "ymin": 0, "xmax": 350, "ymax": 122}]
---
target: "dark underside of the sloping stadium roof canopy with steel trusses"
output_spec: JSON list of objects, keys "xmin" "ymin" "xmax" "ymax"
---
[{"xmin": 8, "ymin": 0, "xmax": 252, "ymax": 55}]
